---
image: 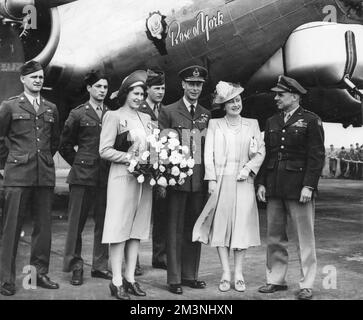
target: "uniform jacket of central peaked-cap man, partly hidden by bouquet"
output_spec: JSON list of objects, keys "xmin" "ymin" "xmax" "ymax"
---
[{"xmin": 159, "ymin": 99, "xmax": 211, "ymax": 192}]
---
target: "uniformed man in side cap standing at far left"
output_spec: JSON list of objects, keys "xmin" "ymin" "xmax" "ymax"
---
[{"xmin": 0, "ymin": 61, "xmax": 59, "ymax": 296}]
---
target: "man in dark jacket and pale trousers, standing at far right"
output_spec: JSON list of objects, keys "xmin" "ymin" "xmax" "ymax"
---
[{"xmin": 257, "ymin": 76, "xmax": 325, "ymax": 300}]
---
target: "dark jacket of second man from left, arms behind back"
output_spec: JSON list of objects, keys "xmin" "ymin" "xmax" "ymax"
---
[{"xmin": 59, "ymin": 102, "xmax": 109, "ymax": 187}]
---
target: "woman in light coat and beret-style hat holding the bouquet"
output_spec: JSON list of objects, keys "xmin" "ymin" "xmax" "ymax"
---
[{"xmin": 100, "ymin": 70, "xmax": 152, "ymax": 300}]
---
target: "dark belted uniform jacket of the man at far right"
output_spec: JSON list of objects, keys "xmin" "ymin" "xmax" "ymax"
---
[{"xmin": 256, "ymin": 107, "xmax": 325, "ymax": 199}]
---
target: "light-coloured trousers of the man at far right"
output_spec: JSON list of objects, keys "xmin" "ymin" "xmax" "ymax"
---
[{"xmin": 266, "ymin": 198, "xmax": 317, "ymax": 289}]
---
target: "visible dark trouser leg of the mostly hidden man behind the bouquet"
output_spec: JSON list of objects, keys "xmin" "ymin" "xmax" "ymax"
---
[{"xmin": 152, "ymin": 188, "xmax": 168, "ymax": 264}]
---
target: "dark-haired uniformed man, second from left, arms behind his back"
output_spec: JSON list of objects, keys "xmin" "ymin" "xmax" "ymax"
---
[{"xmin": 59, "ymin": 71, "xmax": 112, "ymax": 286}]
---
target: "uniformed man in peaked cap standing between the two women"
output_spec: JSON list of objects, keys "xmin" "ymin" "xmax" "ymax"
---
[{"xmin": 159, "ymin": 66, "xmax": 210, "ymax": 294}]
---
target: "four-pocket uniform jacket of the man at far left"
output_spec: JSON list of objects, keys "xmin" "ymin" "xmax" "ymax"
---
[{"xmin": 0, "ymin": 94, "xmax": 59, "ymax": 187}]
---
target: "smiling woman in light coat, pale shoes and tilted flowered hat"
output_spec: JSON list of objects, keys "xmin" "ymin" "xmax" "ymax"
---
[{"xmin": 193, "ymin": 81, "xmax": 265, "ymax": 291}]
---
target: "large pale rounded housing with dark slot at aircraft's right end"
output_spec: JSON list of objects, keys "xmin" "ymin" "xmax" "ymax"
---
[{"xmin": 247, "ymin": 22, "xmax": 363, "ymax": 90}]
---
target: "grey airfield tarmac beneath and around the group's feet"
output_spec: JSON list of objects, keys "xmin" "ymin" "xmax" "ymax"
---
[{"xmin": 0, "ymin": 178, "xmax": 363, "ymax": 302}]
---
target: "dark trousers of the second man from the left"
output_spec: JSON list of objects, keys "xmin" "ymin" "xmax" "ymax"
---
[{"xmin": 63, "ymin": 185, "xmax": 108, "ymax": 272}]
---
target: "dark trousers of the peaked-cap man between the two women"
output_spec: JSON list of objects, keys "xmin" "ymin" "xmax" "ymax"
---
[{"xmin": 167, "ymin": 190, "xmax": 206, "ymax": 284}]
